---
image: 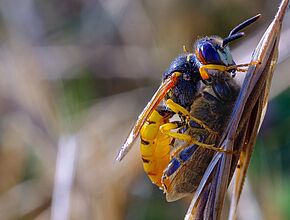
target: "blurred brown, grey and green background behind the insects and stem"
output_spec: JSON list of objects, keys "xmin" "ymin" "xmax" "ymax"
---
[{"xmin": 0, "ymin": 0, "xmax": 290, "ymax": 220}]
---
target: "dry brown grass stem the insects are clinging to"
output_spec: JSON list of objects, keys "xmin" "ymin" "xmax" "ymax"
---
[{"xmin": 185, "ymin": 0, "xmax": 289, "ymax": 219}]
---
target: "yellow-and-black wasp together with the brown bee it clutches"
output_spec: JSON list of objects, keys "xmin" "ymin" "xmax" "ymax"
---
[{"xmin": 116, "ymin": 12, "xmax": 260, "ymax": 218}]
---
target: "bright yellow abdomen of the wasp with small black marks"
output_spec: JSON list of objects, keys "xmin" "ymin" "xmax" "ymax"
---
[{"xmin": 140, "ymin": 110, "xmax": 172, "ymax": 187}]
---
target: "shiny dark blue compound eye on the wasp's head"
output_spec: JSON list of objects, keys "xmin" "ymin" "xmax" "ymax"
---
[{"xmin": 199, "ymin": 43, "xmax": 222, "ymax": 64}]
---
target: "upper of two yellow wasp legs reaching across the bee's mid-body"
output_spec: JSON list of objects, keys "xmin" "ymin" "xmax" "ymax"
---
[{"xmin": 166, "ymin": 99, "xmax": 218, "ymax": 135}]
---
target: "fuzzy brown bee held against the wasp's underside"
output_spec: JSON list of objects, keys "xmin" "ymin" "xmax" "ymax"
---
[{"xmin": 166, "ymin": 72, "xmax": 240, "ymax": 201}]
